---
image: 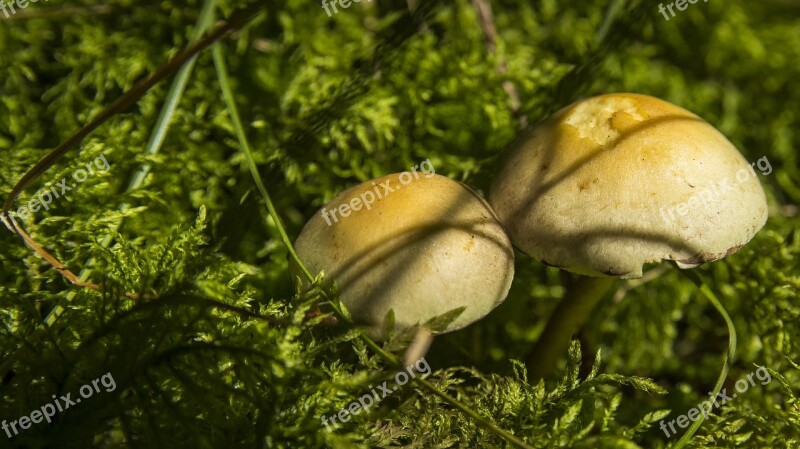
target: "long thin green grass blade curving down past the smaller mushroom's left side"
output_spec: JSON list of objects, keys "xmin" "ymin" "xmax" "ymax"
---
[{"xmin": 211, "ymin": 37, "xmax": 532, "ymax": 449}]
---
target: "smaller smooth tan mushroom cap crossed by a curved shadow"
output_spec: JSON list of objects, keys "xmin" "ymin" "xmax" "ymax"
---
[{"xmin": 295, "ymin": 172, "xmax": 514, "ymax": 335}]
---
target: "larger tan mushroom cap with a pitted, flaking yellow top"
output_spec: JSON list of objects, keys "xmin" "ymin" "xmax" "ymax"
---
[{"xmin": 489, "ymin": 94, "xmax": 767, "ymax": 278}]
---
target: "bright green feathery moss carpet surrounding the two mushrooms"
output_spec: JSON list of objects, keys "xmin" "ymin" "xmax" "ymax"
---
[{"xmin": 0, "ymin": 0, "xmax": 800, "ymax": 448}]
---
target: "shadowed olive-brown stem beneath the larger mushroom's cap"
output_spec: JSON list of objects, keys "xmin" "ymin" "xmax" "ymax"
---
[{"xmin": 526, "ymin": 276, "xmax": 615, "ymax": 381}]
